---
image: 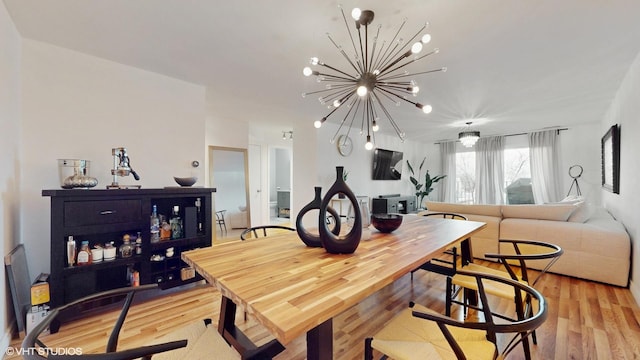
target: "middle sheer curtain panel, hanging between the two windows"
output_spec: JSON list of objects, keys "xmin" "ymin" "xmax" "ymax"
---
[{"xmin": 475, "ymin": 136, "xmax": 504, "ymax": 204}]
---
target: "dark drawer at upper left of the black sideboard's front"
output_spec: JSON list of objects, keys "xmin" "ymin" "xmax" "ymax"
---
[{"xmin": 64, "ymin": 200, "xmax": 142, "ymax": 226}]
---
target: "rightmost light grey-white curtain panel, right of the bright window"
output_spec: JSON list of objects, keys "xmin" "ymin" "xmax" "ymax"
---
[{"xmin": 529, "ymin": 130, "xmax": 562, "ymax": 204}]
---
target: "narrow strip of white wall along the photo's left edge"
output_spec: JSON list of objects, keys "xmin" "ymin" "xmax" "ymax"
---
[{"xmin": 0, "ymin": 3, "xmax": 22, "ymax": 348}]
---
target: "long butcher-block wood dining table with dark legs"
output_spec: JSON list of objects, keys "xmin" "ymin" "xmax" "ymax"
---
[{"xmin": 181, "ymin": 214, "xmax": 486, "ymax": 360}]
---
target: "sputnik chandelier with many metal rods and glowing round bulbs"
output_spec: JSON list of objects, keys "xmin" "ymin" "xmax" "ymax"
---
[{"xmin": 302, "ymin": 7, "xmax": 447, "ymax": 150}]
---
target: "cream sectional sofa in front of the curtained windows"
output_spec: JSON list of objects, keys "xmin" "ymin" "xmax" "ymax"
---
[{"xmin": 427, "ymin": 202, "xmax": 631, "ymax": 287}]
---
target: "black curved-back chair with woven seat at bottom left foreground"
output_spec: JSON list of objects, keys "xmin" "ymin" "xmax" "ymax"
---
[{"xmin": 21, "ymin": 284, "xmax": 240, "ymax": 360}]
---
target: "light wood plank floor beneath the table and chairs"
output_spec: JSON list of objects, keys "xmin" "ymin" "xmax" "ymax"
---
[{"xmin": 5, "ymin": 262, "xmax": 640, "ymax": 360}]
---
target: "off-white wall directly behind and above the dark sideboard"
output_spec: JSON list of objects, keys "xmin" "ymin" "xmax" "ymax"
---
[{"xmin": 21, "ymin": 40, "xmax": 206, "ymax": 274}]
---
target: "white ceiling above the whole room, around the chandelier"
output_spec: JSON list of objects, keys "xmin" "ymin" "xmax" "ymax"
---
[{"xmin": 4, "ymin": 0, "xmax": 640, "ymax": 141}]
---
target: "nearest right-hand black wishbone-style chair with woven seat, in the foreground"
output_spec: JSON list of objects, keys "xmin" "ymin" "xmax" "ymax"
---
[{"xmin": 364, "ymin": 270, "xmax": 548, "ymax": 360}]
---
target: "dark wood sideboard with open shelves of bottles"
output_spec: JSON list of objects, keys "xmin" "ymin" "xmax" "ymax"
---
[{"xmin": 42, "ymin": 187, "xmax": 216, "ymax": 307}]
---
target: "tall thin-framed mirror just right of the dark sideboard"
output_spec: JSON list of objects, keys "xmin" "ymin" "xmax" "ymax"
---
[{"xmin": 209, "ymin": 146, "xmax": 251, "ymax": 240}]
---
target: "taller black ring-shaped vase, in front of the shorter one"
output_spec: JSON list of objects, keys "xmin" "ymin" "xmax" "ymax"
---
[{"xmin": 318, "ymin": 166, "xmax": 362, "ymax": 254}]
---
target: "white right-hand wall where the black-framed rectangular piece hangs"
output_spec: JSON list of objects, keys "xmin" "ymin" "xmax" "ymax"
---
[{"xmin": 600, "ymin": 51, "xmax": 640, "ymax": 303}]
